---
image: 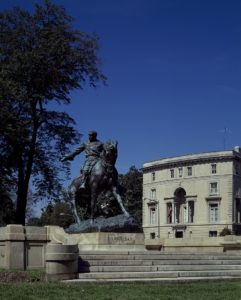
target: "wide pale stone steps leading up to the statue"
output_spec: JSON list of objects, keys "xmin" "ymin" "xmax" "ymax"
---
[{"xmin": 65, "ymin": 251, "xmax": 241, "ymax": 282}]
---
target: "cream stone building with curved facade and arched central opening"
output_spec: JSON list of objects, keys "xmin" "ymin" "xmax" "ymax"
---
[{"xmin": 143, "ymin": 147, "xmax": 241, "ymax": 250}]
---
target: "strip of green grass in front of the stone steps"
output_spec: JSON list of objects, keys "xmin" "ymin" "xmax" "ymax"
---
[{"xmin": 0, "ymin": 281, "xmax": 241, "ymax": 300}]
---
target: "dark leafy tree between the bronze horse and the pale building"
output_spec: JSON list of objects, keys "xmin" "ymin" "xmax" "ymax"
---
[{"xmin": 119, "ymin": 166, "xmax": 143, "ymax": 225}]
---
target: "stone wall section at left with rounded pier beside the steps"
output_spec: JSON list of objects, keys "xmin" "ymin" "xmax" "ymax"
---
[{"xmin": 0, "ymin": 225, "xmax": 79, "ymax": 280}]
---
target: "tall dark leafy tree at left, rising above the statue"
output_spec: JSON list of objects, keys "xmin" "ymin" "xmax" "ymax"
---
[{"xmin": 0, "ymin": 0, "xmax": 105, "ymax": 225}]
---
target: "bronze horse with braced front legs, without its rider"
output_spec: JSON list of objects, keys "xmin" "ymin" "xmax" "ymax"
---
[{"xmin": 68, "ymin": 140, "xmax": 129, "ymax": 224}]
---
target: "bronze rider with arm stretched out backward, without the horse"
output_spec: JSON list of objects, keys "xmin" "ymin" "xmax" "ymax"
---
[{"xmin": 61, "ymin": 131, "xmax": 104, "ymax": 189}]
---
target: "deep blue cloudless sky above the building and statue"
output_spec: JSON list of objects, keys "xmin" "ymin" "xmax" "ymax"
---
[{"xmin": 0, "ymin": 0, "xmax": 241, "ymax": 177}]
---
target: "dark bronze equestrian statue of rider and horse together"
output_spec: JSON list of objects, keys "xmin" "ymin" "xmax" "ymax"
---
[{"xmin": 61, "ymin": 131, "xmax": 129, "ymax": 224}]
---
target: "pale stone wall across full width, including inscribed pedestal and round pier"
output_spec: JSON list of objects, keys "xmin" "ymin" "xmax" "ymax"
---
[{"xmin": 0, "ymin": 225, "xmax": 241, "ymax": 279}]
